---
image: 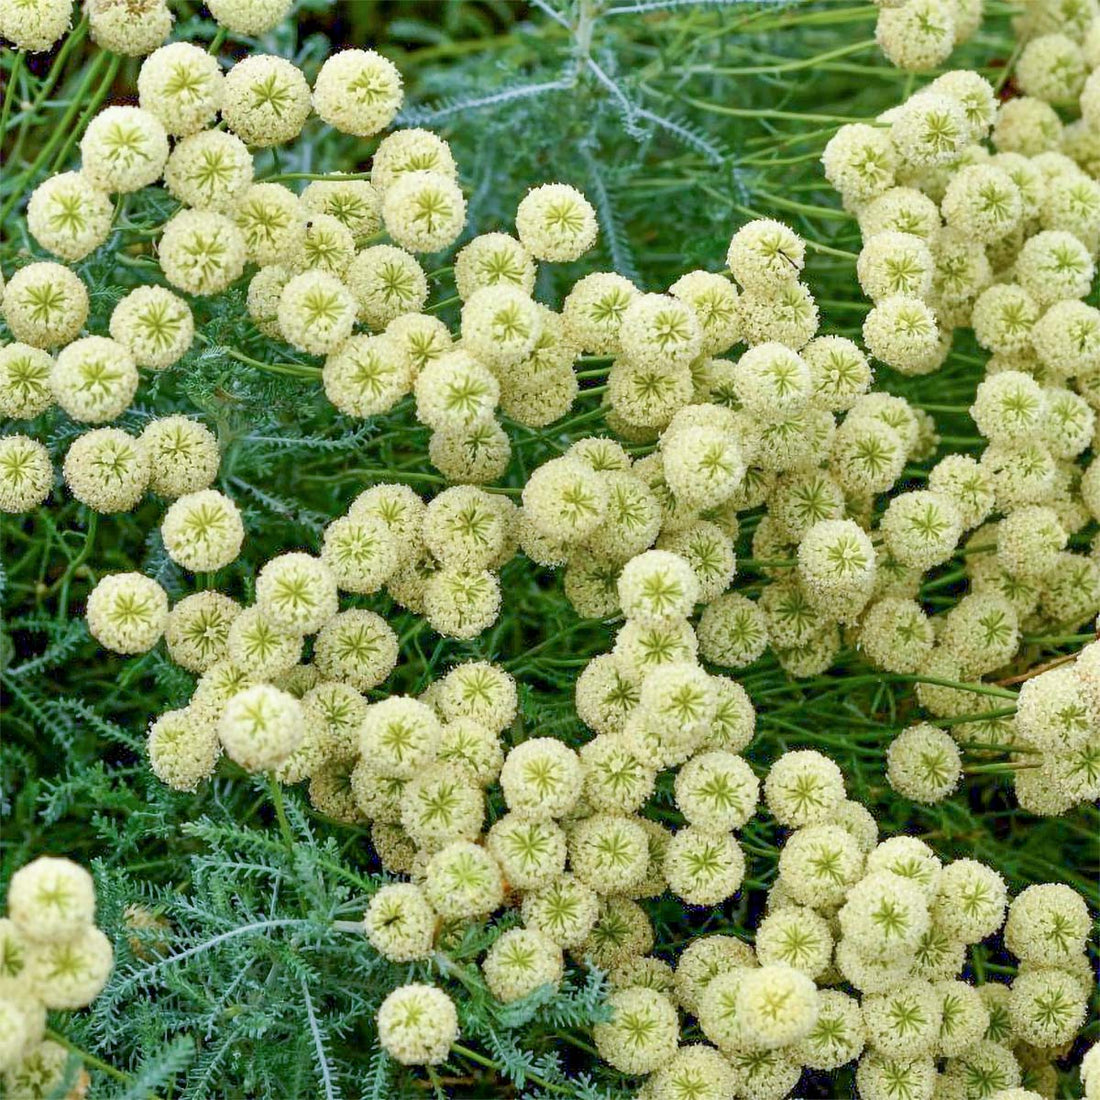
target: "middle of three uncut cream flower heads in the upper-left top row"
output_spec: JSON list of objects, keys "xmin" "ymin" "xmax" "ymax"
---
[{"xmin": 221, "ymin": 55, "xmax": 311, "ymax": 146}]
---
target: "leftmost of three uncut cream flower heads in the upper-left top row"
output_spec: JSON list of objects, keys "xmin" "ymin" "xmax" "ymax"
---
[{"xmin": 137, "ymin": 42, "xmax": 223, "ymax": 137}]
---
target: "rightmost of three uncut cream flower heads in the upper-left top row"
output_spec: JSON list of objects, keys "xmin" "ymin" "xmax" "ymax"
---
[{"xmin": 314, "ymin": 50, "xmax": 404, "ymax": 138}]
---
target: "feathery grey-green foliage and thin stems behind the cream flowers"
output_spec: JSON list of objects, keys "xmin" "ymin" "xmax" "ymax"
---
[{"xmin": 0, "ymin": 0, "xmax": 1098, "ymax": 1100}]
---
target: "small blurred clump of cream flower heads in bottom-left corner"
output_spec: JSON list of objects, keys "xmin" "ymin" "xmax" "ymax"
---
[{"xmin": 0, "ymin": 856, "xmax": 114, "ymax": 1097}]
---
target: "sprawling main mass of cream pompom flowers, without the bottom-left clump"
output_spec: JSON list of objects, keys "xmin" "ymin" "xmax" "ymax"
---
[{"xmin": 0, "ymin": 0, "xmax": 1100, "ymax": 1100}]
